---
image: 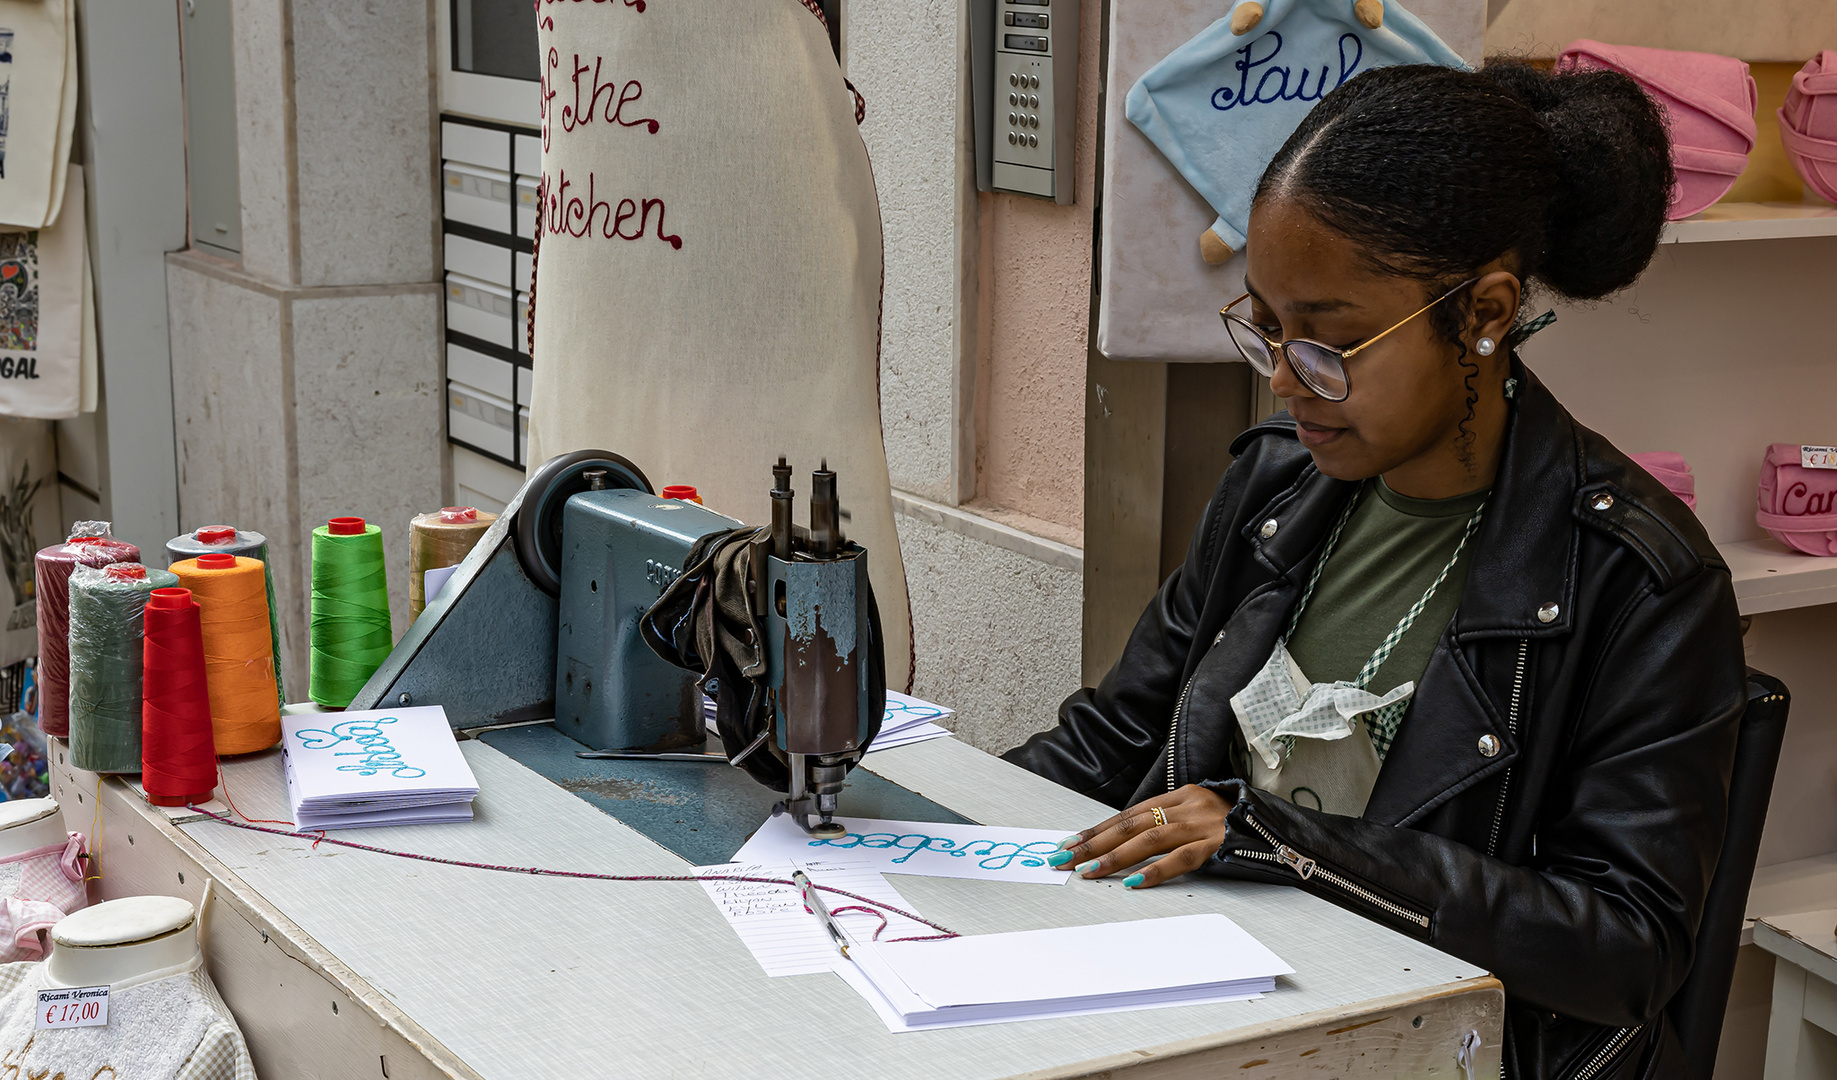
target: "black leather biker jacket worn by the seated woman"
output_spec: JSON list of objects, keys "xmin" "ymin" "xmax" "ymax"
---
[{"xmin": 1005, "ymin": 366, "xmax": 1745, "ymax": 1080}]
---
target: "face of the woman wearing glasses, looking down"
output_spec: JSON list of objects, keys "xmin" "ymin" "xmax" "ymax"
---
[{"xmin": 1240, "ymin": 195, "xmax": 1517, "ymax": 498}]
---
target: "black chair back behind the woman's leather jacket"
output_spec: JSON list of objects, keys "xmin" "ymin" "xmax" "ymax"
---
[{"xmin": 1664, "ymin": 669, "xmax": 1793, "ymax": 1080}]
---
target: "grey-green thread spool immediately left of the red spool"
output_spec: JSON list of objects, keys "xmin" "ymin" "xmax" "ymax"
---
[{"xmin": 70, "ymin": 562, "xmax": 178, "ymax": 773}]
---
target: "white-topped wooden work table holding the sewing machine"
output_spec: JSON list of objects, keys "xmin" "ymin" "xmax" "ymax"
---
[{"xmin": 53, "ymin": 738, "xmax": 1505, "ymax": 1080}]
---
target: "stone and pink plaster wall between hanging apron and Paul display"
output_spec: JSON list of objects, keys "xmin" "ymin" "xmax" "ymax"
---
[{"xmin": 845, "ymin": 0, "xmax": 1100, "ymax": 751}]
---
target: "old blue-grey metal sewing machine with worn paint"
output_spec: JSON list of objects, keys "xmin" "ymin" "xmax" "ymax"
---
[{"xmin": 351, "ymin": 450, "xmax": 884, "ymax": 836}]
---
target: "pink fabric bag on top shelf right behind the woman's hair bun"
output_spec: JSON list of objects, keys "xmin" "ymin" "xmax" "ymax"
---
[{"xmin": 1556, "ymin": 39, "xmax": 1760, "ymax": 220}]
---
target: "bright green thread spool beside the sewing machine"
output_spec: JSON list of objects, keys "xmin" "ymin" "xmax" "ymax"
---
[{"xmin": 309, "ymin": 518, "xmax": 395, "ymax": 709}]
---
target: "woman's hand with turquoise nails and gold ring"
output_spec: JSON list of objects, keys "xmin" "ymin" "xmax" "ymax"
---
[{"xmin": 1047, "ymin": 784, "xmax": 1231, "ymax": 889}]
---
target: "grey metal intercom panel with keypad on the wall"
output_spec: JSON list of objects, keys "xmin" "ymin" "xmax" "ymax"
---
[{"xmin": 970, "ymin": 0, "xmax": 1078, "ymax": 204}]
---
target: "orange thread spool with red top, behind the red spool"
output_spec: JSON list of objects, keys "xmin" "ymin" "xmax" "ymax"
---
[{"xmin": 173, "ymin": 551, "xmax": 281, "ymax": 755}]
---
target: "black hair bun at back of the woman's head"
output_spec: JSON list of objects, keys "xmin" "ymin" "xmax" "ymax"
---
[{"xmin": 1481, "ymin": 61, "xmax": 1675, "ymax": 299}]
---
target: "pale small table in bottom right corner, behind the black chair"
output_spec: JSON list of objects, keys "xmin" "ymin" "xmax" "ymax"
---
[{"xmin": 1754, "ymin": 911, "xmax": 1837, "ymax": 1080}]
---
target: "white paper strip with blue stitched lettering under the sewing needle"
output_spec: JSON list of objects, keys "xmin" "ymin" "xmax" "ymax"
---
[{"xmin": 733, "ymin": 814, "xmax": 1071, "ymax": 885}]
